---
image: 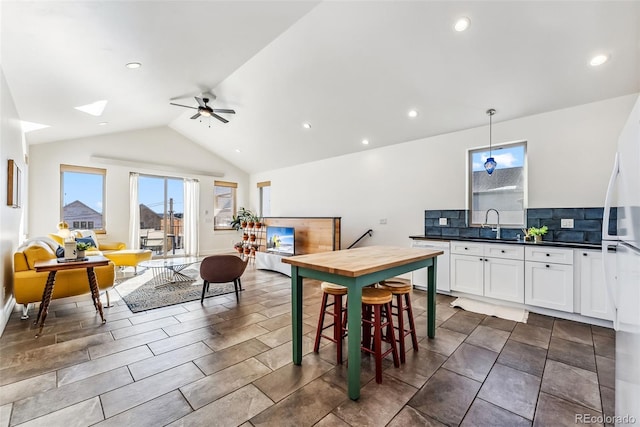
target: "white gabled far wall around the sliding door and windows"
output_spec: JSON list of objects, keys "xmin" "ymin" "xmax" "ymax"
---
[{"xmin": 29, "ymin": 127, "xmax": 249, "ymax": 255}]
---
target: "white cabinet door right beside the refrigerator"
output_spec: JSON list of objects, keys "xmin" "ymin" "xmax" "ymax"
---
[{"xmin": 575, "ymin": 250, "xmax": 614, "ymax": 320}]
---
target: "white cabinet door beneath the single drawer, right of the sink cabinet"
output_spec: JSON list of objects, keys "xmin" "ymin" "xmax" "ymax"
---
[{"xmin": 524, "ymin": 261, "xmax": 573, "ymax": 312}]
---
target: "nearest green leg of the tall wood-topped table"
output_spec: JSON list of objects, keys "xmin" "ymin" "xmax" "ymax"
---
[{"xmin": 347, "ymin": 283, "xmax": 362, "ymax": 400}]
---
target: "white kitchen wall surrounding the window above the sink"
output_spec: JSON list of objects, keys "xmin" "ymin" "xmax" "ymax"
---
[{"xmin": 250, "ymin": 94, "xmax": 637, "ymax": 247}]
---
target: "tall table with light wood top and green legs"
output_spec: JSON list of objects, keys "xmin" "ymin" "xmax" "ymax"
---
[{"xmin": 282, "ymin": 246, "xmax": 444, "ymax": 400}]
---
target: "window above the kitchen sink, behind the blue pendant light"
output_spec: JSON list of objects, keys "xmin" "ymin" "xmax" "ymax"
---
[{"xmin": 468, "ymin": 141, "xmax": 527, "ymax": 227}]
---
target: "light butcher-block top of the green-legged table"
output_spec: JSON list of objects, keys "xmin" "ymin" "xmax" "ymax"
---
[{"xmin": 282, "ymin": 246, "xmax": 444, "ymax": 277}]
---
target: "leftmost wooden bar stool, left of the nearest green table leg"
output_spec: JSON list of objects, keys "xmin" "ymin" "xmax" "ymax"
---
[{"xmin": 313, "ymin": 282, "xmax": 347, "ymax": 364}]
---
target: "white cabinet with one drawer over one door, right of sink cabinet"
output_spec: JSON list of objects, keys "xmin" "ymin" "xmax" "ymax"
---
[{"xmin": 524, "ymin": 247, "xmax": 573, "ymax": 312}]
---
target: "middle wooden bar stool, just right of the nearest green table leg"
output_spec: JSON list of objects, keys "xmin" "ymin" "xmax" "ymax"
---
[{"xmin": 361, "ymin": 288, "xmax": 400, "ymax": 384}]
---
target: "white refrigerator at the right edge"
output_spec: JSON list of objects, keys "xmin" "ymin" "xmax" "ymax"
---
[{"xmin": 602, "ymin": 93, "xmax": 640, "ymax": 425}]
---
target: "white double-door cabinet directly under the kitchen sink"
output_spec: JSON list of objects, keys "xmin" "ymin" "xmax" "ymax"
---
[{"xmin": 451, "ymin": 241, "xmax": 524, "ymax": 303}]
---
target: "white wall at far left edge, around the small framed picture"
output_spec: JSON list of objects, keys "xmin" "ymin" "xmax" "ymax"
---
[{"xmin": 0, "ymin": 67, "xmax": 28, "ymax": 334}]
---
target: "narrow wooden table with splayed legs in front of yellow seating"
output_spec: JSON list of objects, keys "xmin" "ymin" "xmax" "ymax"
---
[{"xmin": 33, "ymin": 256, "xmax": 109, "ymax": 338}]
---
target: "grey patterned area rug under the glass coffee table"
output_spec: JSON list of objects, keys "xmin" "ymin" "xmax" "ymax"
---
[{"xmin": 115, "ymin": 268, "xmax": 235, "ymax": 313}]
